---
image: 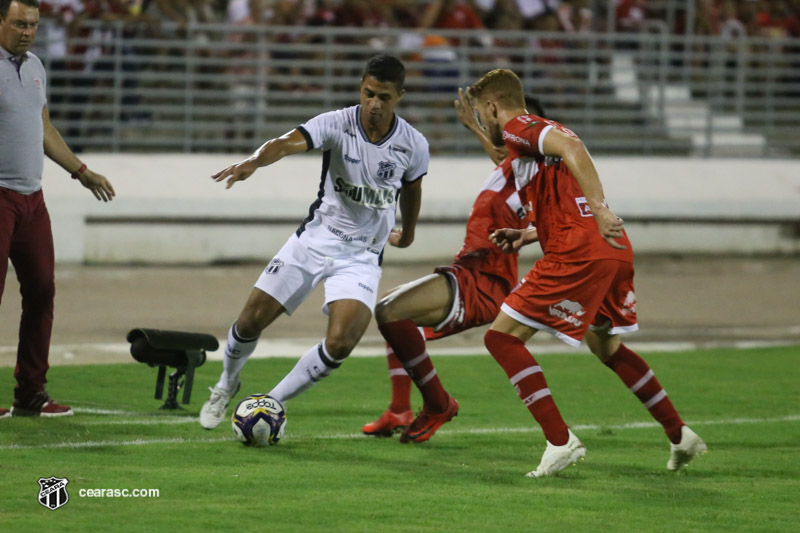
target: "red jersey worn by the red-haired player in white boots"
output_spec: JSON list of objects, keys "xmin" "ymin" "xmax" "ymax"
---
[{"xmin": 503, "ymin": 115, "xmax": 633, "ymax": 263}]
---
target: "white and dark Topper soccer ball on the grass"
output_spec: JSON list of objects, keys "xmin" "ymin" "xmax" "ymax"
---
[{"xmin": 232, "ymin": 394, "xmax": 286, "ymax": 447}]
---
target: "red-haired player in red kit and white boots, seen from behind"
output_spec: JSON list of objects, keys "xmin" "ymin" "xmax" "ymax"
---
[{"xmin": 468, "ymin": 69, "xmax": 706, "ymax": 477}]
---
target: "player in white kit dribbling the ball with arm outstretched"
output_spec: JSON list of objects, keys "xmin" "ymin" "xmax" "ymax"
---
[{"xmin": 200, "ymin": 55, "xmax": 429, "ymax": 429}]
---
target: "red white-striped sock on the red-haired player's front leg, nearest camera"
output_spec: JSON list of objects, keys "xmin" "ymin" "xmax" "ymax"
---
[{"xmin": 483, "ymin": 330, "xmax": 569, "ymax": 446}]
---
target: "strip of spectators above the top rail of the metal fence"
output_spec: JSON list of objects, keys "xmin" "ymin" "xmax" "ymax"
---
[{"xmin": 36, "ymin": 0, "xmax": 800, "ymax": 37}]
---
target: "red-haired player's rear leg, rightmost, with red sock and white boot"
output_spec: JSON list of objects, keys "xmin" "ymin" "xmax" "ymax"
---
[{"xmin": 585, "ymin": 328, "xmax": 707, "ymax": 470}]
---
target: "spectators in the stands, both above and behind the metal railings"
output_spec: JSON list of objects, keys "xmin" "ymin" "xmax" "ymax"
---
[{"xmin": 29, "ymin": 0, "xmax": 800, "ymax": 150}]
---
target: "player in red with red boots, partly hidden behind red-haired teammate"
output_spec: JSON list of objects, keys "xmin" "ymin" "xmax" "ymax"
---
[{"xmin": 361, "ymin": 91, "xmax": 535, "ymax": 443}]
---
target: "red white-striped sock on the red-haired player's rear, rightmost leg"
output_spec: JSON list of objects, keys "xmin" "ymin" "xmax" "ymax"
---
[{"xmin": 603, "ymin": 344, "xmax": 684, "ymax": 444}]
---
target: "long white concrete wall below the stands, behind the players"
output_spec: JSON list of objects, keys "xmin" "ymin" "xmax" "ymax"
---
[{"xmin": 44, "ymin": 154, "xmax": 800, "ymax": 263}]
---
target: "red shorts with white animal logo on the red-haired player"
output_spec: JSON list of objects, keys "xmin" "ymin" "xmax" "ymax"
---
[{"xmin": 502, "ymin": 259, "xmax": 639, "ymax": 346}]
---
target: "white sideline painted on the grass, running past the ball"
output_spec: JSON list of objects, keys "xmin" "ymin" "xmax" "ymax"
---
[{"xmin": 0, "ymin": 414, "xmax": 800, "ymax": 450}]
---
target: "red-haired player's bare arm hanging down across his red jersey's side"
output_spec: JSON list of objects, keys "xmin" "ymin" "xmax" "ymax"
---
[{"xmin": 542, "ymin": 128, "xmax": 625, "ymax": 250}]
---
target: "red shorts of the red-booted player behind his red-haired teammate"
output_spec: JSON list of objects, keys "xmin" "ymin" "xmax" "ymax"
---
[{"xmin": 423, "ymin": 265, "xmax": 508, "ymax": 340}]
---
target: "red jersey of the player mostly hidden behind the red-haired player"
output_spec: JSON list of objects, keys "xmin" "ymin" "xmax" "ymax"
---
[{"xmin": 453, "ymin": 158, "xmax": 529, "ymax": 290}]
